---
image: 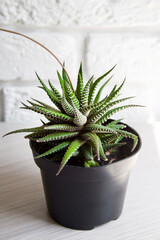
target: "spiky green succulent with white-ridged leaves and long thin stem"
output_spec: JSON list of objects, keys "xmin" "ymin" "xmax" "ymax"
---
[{"xmin": 0, "ymin": 28, "xmax": 140, "ymax": 175}]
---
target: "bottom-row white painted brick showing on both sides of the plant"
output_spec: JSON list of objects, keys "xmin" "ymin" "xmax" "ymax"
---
[{"xmin": 3, "ymin": 81, "xmax": 156, "ymax": 122}]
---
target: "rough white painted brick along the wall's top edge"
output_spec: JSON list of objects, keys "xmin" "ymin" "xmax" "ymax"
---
[{"xmin": 0, "ymin": 0, "xmax": 160, "ymax": 27}]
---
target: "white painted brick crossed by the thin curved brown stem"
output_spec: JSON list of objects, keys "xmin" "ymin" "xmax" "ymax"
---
[{"xmin": 0, "ymin": 31, "xmax": 77, "ymax": 81}]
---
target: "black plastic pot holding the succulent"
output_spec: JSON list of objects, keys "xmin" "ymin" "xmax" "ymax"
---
[{"xmin": 30, "ymin": 123, "xmax": 141, "ymax": 230}]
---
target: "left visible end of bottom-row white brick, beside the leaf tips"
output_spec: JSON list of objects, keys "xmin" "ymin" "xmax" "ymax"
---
[{"xmin": 3, "ymin": 86, "xmax": 61, "ymax": 122}]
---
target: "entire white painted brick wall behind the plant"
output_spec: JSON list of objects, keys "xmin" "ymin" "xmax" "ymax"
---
[{"xmin": 0, "ymin": 0, "xmax": 160, "ymax": 122}]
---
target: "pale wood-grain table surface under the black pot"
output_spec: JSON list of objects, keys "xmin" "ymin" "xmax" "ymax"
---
[{"xmin": 0, "ymin": 123, "xmax": 160, "ymax": 240}]
